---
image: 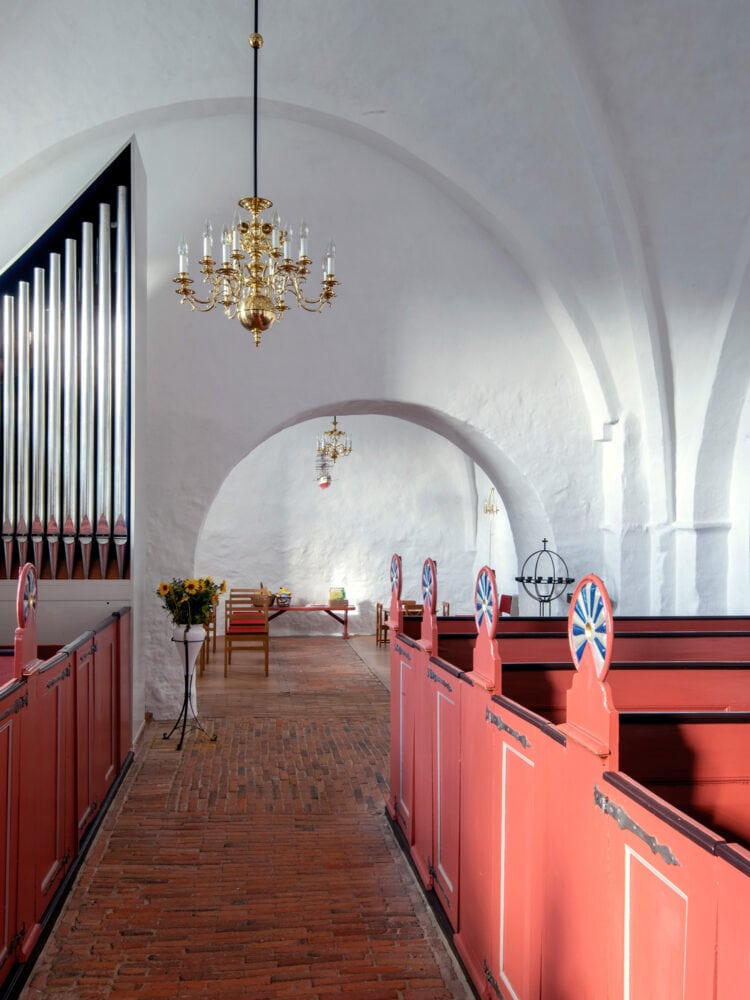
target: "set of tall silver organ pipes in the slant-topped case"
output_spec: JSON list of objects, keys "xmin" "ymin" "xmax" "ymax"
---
[{"xmin": 0, "ymin": 168, "xmax": 131, "ymax": 579}]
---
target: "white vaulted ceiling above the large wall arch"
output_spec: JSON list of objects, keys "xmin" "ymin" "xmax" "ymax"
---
[{"xmin": 0, "ymin": 0, "xmax": 750, "ymax": 458}]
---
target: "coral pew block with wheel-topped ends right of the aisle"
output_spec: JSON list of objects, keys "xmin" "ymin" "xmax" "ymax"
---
[{"xmin": 388, "ymin": 557, "xmax": 750, "ymax": 1000}]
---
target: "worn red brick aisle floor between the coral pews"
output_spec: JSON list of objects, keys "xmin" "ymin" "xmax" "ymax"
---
[{"xmin": 21, "ymin": 638, "xmax": 473, "ymax": 1000}]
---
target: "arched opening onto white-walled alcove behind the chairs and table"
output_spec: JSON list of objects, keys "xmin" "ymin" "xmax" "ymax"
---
[{"xmin": 196, "ymin": 414, "xmax": 518, "ymax": 634}]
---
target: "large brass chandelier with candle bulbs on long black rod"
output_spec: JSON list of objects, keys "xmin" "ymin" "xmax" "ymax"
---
[{"xmin": 174, "ymin": 0, "xmax": 339, "ymax": 347}]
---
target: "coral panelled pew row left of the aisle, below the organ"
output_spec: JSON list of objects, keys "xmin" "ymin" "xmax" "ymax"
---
[{"xmin": 0, "ymin": 564, "xmax": 132, "ymax": 996}]
